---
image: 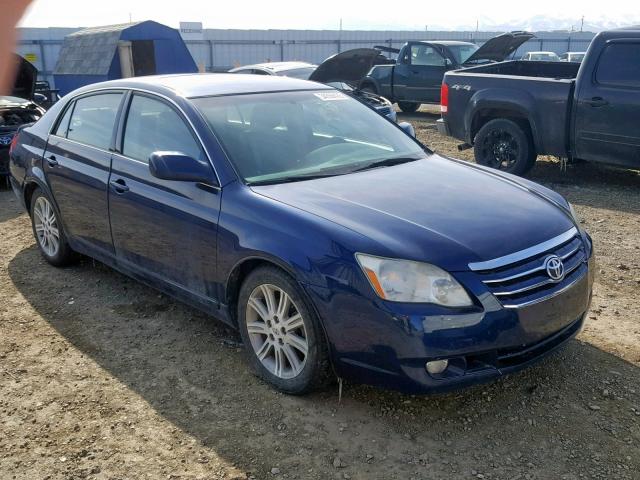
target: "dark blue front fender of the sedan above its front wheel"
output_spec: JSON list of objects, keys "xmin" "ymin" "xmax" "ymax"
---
[{"xmin": 218, "ymin": 182, "xmax": 371, "ymax": 294}]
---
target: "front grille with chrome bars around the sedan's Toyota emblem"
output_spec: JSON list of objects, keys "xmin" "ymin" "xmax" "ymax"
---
[{"xmin": 469, "ymin": 228, "xmax": 587, "ymax": 308}]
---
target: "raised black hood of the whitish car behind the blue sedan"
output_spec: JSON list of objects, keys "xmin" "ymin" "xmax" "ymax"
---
[{"xmin": 309, "ymin": 48, "xmax": 393, "ymax": 85}]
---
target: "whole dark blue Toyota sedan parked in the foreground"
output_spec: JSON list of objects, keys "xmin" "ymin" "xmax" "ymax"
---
[{"xmin": 10, "ymin": 74, "xmax": 594, "ymax": 394}]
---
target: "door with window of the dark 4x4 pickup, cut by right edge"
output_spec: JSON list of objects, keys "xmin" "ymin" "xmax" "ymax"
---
[{"xmin": 574, "ymin": 39, "xmax": 640, "ymax": 166}]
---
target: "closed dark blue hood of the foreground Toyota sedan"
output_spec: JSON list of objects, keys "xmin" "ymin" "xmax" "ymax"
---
[{"xmin": 251, "ymin": 155, "xmax": 574, "ymax": 271}]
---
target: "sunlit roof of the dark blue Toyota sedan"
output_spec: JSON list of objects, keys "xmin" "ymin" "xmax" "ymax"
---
[{"xmin": 68, "ymin": 73, "xmax": 331, "ymax": 98}]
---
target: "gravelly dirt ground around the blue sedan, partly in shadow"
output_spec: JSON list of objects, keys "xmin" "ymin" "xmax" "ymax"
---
[{"xmin": 0, "ymin": 111, "xmax": 640, "ymax": 480}]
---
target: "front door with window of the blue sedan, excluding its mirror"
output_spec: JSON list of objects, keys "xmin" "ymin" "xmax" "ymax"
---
[{"xmin": 109, "ymin": 93, "xmax": 221, "ymax": 302}]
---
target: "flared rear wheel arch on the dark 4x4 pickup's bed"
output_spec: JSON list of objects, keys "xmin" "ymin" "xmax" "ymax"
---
[{"xmin": 464, "ymin": 88, "xmax": 541, "ymax": 151}]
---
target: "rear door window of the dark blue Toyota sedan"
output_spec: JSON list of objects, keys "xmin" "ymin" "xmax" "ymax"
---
[{"xmin": 67, "ymin": 93, "xmax": 122, "ymax": 150}]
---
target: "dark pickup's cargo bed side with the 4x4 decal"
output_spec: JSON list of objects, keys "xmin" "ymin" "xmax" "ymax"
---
[{"xmin": 445, "ymin": 61, "xmax": 580, "ymax": 156}]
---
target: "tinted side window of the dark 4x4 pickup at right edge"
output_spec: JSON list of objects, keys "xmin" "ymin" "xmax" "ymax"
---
[{"xmin": 596, "ymin": 43, "xmax": 640, "ymax": 88}]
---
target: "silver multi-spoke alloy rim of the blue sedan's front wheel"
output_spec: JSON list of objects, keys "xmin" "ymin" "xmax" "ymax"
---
[{"xmin": 245, "ymin": 284, "xmax": 309, "ymax": 379}]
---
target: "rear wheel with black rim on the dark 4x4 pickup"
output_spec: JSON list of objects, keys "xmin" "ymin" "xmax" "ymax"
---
[{"xmin": 473, "ymin": 118, "xmax": 537, "ymax": 175}]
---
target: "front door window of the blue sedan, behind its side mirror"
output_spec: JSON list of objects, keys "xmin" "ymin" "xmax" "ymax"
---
[{"xmin": 122, "ymin": 95, "xmax": 205, "ymax": 162}]
